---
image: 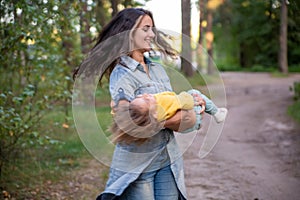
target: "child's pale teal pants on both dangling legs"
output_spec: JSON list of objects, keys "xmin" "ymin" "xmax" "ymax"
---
[{"xmin": 181, "ymin": 89, "xmax": 218, "ymax": 133}]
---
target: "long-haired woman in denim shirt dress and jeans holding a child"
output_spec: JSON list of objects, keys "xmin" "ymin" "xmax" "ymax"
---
[{"xmin": 75, "ymin": 8, "xmax": 205, "ymax": 200}]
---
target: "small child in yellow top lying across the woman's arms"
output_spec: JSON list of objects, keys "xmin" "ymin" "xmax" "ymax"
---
[{"xmin": 111, "ymin": 89, "xmax": 227, "ymax": 144}]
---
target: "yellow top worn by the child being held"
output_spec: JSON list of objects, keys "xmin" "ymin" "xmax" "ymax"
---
[{"xmin": 154, "ymin": 92, "xmax": 194, "ymax": 122}]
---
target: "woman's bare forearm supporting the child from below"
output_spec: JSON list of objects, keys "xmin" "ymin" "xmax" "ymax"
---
[{"xmin": 164, "ymin": 109, "xmax": 196, "ymax": 131}]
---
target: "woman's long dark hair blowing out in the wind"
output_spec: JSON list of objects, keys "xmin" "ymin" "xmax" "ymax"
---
[{"xmin": 73, "ymin": 8, "xmax": 177, "ymax": 82}]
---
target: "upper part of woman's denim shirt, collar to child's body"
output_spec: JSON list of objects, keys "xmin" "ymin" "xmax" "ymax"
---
[{"xmin": 109, "ymin": 56, "xmax": 172, "ymax": 104}]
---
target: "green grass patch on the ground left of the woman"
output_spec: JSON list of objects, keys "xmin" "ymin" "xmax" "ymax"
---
[{"xmin": 0, "ymin": 107, "xmax": 89, "ymax": 199}]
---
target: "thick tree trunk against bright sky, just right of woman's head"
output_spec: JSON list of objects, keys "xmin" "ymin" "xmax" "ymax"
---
[{"xmin": 181, "ymin": 0, "xmax": 194, "ymax": 77}]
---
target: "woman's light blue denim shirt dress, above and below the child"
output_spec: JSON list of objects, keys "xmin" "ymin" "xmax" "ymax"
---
[{"xmin": 98, "ymin": 56, "xmax": 186, "ymax": 200}]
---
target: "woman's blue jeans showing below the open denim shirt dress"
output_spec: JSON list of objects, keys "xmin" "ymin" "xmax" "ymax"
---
[{"xmin": 119, "ymin": 165, "xmax": 180, "ymax": 200}]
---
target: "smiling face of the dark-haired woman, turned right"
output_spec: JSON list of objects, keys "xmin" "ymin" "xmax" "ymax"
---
[{"xmin": 133, "ymin": 15, "xmax": 155, "ymax": 52}]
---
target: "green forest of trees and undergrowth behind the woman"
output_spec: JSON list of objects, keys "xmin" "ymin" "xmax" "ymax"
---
[{"xmin": 0, "ymin": 0, "xmax": 300, "ymax": 199}]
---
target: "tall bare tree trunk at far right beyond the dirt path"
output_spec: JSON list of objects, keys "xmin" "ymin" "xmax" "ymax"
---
[{"xmin": 278, "ymin": 0, "xmax": 288, "ymax": 74}]
